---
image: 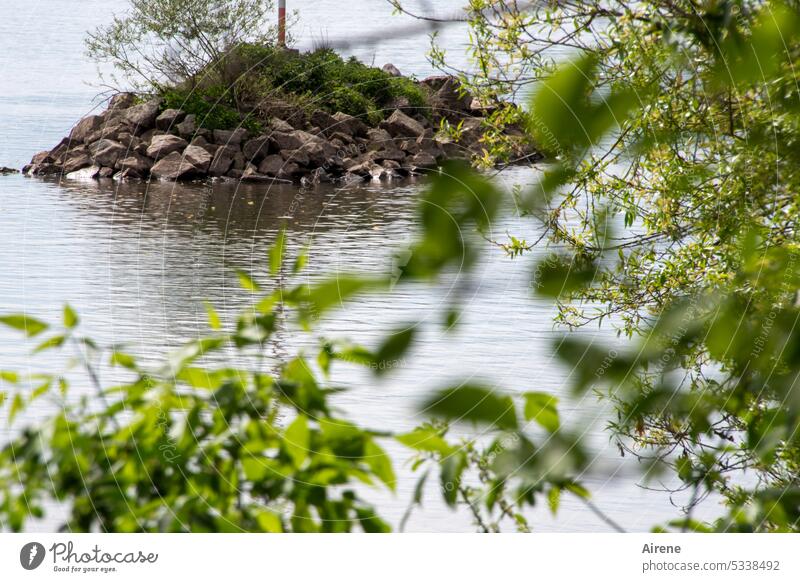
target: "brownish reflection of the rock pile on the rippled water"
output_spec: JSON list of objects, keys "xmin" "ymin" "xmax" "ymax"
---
[{"xmin": 39, "ymin": 180, "xmax": 419, "ymax": 243}]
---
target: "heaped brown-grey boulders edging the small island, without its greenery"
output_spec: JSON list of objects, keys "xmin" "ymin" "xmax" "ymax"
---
[{"xmin": 22, "ymin": 73, "xmax": 537, "ymax": 185}]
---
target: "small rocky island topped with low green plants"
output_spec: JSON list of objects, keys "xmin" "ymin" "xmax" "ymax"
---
[{"xmin": 23, "ymin": 49, "xmax": 537, "ymax": 185}]
